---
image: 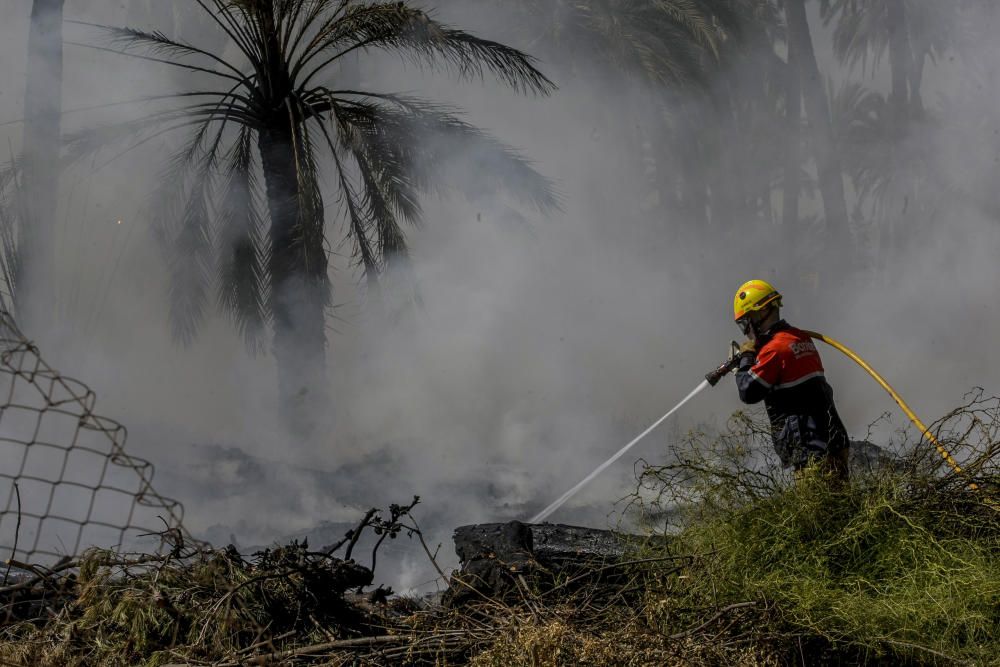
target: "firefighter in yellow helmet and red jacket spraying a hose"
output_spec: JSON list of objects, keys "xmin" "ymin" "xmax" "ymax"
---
[{"xmin": 733, "ymin": 280, "xmax": 849, "ymax": 483}]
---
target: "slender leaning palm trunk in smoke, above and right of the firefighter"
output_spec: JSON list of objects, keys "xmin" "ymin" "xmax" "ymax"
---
[{"xmin": 785, "ymin": 0, "xmax": 851, "ymax": 251}]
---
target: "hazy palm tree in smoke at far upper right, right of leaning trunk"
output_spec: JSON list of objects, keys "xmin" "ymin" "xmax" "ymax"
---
[{"xmin": 820, "ymin": 0, "xmax": 961, "ymax": 272}]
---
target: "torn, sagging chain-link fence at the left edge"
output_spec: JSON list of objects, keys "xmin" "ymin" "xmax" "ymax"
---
[{"xmin": 0, "ymin": 311, "xmax": 186, "ymax": 578}]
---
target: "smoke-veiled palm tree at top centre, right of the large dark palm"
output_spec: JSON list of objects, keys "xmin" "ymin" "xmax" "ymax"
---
[{"xmin": 464, "ymin": 0, "xmax": 748, "ymax": 237}]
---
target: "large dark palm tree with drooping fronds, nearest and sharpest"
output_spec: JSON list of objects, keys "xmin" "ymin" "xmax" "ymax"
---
[{"xmin": 70, "ymin": 0, "xmax": 556, "ymax": 431}]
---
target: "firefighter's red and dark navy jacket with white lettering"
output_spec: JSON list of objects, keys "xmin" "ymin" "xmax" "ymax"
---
[{"xmin": 736, "ymin": 320, "xmax": 848, "ymax": 470}]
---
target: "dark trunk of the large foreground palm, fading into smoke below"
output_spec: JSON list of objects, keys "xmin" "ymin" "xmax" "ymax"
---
[{"xmin": 258, "ymin": 126, "xmax": 329, "ymax": 438}]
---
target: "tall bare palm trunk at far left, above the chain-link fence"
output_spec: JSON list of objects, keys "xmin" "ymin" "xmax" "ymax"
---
[{"xmin": 17, "ymin": 0, "xmax": 64, "ymax": 336}]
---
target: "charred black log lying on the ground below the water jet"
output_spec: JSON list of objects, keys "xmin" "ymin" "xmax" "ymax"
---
[{"xmin": 443, "ymin": 521, "xmax": 648, "ymax": 606}]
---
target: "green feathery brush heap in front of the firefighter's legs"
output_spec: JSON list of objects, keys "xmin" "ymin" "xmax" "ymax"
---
[{"xmin": 634, "ymin": 397, "xmax": 1000, "ymax": 665}]
